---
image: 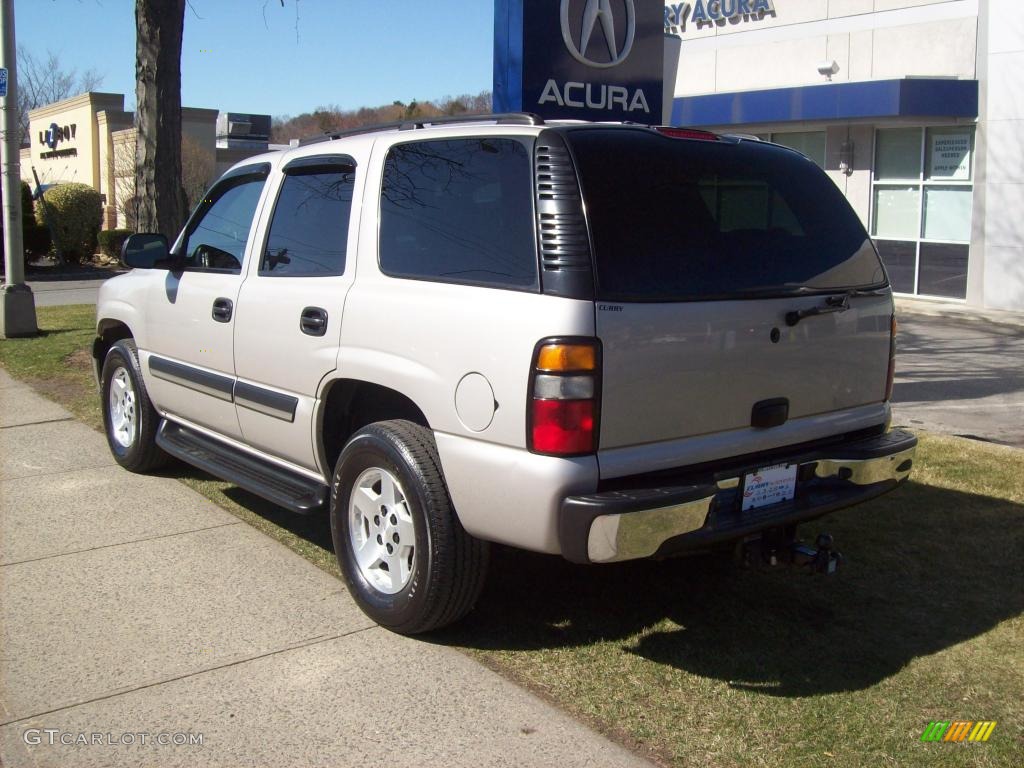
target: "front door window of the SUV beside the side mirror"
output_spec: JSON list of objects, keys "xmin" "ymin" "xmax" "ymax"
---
[{"xmin": 183, "ymin": 175, "xmax": 264, "ymax": 274}]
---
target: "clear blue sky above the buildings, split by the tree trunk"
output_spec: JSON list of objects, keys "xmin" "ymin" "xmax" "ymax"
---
[{"xmin": 14, "ymin": 0, "xmax": 494, "ymax": 116}]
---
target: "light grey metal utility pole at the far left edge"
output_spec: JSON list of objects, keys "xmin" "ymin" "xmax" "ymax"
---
[{"xmin": 0, "ymin": 0, "xmax": 39, "ymax": 339}]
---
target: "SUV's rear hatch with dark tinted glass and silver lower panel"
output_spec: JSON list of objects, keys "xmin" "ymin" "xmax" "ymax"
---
[{"xmin": 565, "ymin": 127, "xmax": 893, "ymax": 462}]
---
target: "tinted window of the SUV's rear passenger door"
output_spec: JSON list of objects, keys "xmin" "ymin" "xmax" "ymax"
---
[{"xmin": 260, "ymin": 171, "xmax": 355, "ymax": 276}]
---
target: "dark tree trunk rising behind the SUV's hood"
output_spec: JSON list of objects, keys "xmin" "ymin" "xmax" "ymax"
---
[{"xmin": 135, "ymin": 0, "xmax": 186, "ymax": 241}]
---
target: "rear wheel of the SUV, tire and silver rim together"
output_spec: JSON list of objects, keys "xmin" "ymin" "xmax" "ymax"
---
[{"xmin": 331, "ymin": 421, "xmax": 489, "ymax": 635}]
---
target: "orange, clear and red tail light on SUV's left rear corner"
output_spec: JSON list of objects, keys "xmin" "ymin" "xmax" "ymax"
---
[{"xmin": 526, "ymin": 339, "xmax": 601, "ymax": 456}]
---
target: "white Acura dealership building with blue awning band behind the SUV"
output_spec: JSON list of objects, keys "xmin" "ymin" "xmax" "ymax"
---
[{"xmin": 665, "ymin": 0, "xmax": 1024, "ymax": 311}]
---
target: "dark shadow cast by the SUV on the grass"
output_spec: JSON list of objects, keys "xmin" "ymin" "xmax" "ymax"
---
[{"xmin": 430, "ymin": 482, "xmax": 1024, "ymax": 696}]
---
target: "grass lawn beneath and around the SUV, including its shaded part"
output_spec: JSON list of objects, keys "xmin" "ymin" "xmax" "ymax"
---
[{"xmin": 0, "ymin": 307, "xmax": 1024, "ymax": 768}]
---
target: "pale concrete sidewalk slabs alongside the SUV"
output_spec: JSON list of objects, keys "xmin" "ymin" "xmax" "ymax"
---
[{"xmin": 0, "ymin": 370, "xmax": 647, "ymax": 768}]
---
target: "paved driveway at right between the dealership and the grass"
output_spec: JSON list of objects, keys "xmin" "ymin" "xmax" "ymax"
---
[{"xmin": 893, "ymin": 314, "xmax": 1024, "ymax": 447}]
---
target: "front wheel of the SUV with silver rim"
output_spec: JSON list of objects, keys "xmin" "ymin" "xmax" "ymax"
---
[{"xmin": 100, "ymin": 339, "xmax": 167, "ymax": 472}]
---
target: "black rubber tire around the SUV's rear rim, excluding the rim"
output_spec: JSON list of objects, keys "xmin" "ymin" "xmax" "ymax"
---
[{"xmin": 331, "ymin": 421, "xmax": 489, "ymax": 635}]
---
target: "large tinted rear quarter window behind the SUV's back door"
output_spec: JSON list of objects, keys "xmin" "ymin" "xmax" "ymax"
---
[{"xmin": 380, "ymin": 138, "xmax": 538, "ymax": 289}]
